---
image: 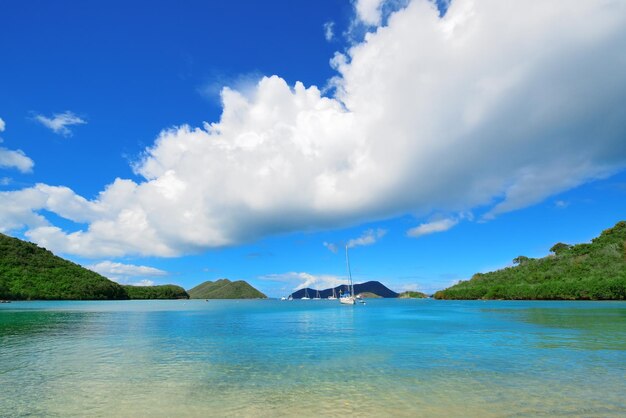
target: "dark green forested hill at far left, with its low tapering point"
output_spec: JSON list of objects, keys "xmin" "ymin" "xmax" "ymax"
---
[{"xmin": 0, "ymin": 234, "xmax": 186, "ymax": 300}]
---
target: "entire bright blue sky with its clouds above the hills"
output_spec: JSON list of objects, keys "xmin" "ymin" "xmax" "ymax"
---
[{"xmin": 0, "ymin": 0, "xmax": 626, "ymax": 297}]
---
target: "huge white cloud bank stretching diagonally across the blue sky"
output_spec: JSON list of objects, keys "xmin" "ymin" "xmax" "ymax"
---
[{"xmin": 0, "ymin": 0, "xmax": 626, "ymax": 257}]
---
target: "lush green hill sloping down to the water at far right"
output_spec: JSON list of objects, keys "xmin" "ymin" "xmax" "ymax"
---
[{"xmin": 434, "ymin": 221, "xmax": 626, "ymax": 300}]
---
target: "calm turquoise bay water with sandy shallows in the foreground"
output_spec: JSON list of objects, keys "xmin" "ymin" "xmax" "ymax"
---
[{"xmin": 0, "ymin": 300, "xmax": 626, "ymax": 417}]
